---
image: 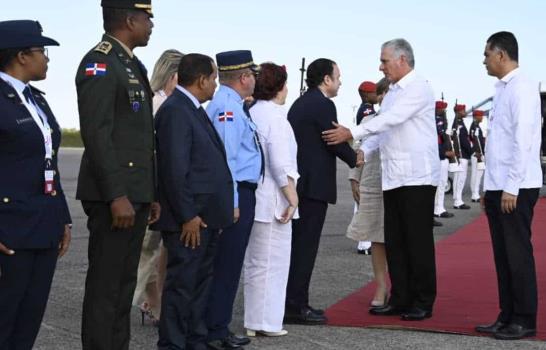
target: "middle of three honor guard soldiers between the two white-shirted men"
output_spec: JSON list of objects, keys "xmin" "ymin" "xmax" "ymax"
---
[{"xmin": 451, "ymin": 104, "xmax": 472, "ymax": 209}]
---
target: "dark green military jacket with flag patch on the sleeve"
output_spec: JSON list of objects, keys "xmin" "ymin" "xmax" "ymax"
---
[{"xmin": 76, "ymin": 35, "xmax": 156, "ymax": 203}]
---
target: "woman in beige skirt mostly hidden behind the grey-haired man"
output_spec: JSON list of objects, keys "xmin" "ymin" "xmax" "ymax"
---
[{"xmin": 347, "ymin": 78, "xmax": 389, "ymax": 307}]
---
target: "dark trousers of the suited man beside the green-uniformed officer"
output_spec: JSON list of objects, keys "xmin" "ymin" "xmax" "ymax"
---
[{"xmin": 157, "ymin": 229, "xmax": 218, "ymax": 350}]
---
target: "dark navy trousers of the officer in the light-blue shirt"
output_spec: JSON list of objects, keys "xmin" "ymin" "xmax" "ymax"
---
[{"xmin": 207, "ymin": 183, "xmax": 256, "ymax": 340}]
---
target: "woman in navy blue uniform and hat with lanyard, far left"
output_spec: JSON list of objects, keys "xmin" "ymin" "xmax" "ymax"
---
[{"xmin": 0, "ymin": 20, "xmax": 70, "ymax": 350}]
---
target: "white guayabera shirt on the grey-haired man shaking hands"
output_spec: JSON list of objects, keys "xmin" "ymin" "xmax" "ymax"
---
[{"xmin": 351, "ymin": 70, "xmax": 440, "ymax": 191}]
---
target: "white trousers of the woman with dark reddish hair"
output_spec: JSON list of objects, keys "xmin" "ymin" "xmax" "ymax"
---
[{"xmin": 244, "ymin": 220, "xmax": 292, "ymax": 332}]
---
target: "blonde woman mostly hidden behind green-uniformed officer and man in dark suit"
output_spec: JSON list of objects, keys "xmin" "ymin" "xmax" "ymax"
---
[{"xmin": 133, "ymin": 50, "xmax": 183, "ymax": 325}]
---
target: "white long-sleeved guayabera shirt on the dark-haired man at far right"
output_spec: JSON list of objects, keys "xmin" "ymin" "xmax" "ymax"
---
[{"xmin": 484, "ymin": 68, "xmax": 542, "ymax": 196}]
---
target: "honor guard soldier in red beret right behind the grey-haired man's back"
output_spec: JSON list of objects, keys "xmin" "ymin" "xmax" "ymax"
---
[{"xmin": 434, "ymin": 101, "xmax": 454, "ymax": 220}]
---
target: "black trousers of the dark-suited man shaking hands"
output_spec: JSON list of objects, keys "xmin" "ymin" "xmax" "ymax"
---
[{"xmin": 286, "ymin": 197, "xmax": 328, "ymax": 311}]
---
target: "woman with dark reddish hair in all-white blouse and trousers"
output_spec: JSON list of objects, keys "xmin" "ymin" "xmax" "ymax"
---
[{"xmin": 244, "ymin": 63, "xmax": 299, "ymax": 336}]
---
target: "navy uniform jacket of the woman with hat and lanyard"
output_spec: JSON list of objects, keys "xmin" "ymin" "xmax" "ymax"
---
[{"xmin": 0, "ymin": 79, "xmax": 71, "ymax": 250}]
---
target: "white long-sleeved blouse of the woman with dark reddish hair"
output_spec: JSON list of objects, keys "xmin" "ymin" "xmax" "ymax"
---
[{"xmin": 250, "ymin": 100, "xmax": 299, "ymax": 222}]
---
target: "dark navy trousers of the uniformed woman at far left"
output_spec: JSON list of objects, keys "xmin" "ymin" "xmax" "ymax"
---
[{"xmin": 0, "ymin": 248, "xmax": 59, "ymax": 350}]
